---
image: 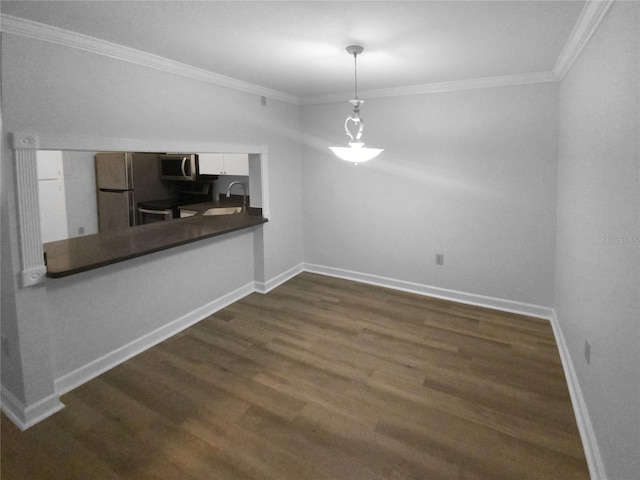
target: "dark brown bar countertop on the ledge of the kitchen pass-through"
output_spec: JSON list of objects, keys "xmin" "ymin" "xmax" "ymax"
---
[{"xmin": 44, "ymin": 213, "xmax": 267, "ymax": 278}]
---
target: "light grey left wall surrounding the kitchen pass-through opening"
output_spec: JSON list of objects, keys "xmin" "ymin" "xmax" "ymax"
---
[{"xmin": 1, "ymin": 33, "xmax": 302, "ymax": 414}]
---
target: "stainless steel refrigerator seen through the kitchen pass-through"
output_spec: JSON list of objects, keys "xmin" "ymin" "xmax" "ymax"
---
[{"xmin": 95, "ymin": 152, "xmax": 176, "ymax": 233}]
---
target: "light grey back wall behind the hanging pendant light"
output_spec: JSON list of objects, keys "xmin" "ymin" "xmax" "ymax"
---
[{"xmin": 303, "ymin": 84, "xmax": 558, "ymax": 307}]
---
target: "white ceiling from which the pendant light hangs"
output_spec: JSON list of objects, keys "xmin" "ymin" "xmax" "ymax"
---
[{"xmin": 0, "ymin": 0, "xmax": 585, "ymax": 98}]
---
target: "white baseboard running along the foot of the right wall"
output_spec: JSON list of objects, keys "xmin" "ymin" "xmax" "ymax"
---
[{"xmin": 551, "ymin": 309, "xmax": 607, "ymax": 480}]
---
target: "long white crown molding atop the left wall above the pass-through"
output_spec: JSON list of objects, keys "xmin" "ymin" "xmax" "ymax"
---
[{"xmin": 0, "ymin": 14, "xmax": 300, "ymax": 105}]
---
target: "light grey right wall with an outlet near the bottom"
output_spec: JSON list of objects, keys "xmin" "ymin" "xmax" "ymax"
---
[{"xmin": 555, "ymin": 2, "xmax": 640, "ymax": 480}]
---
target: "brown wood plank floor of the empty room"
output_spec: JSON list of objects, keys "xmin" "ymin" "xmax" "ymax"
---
[{"xmin": 1, "ymin": 273, "xmax": 589, "ymax": 480}]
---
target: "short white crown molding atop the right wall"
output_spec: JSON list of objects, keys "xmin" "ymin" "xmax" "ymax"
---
[{"xmin": 553, "ymin": 0, "xmax": 614, "ymax": 80}]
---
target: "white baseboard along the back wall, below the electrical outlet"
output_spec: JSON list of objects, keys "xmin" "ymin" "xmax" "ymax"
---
[{"xmin": 303, "ymin": 263, "xmax": 553, "ymax": 321}]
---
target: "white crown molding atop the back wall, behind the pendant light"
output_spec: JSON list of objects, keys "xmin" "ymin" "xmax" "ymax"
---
[{"xmin": 300, "ymin": 72, "xmax": 560, "ymax": 105}]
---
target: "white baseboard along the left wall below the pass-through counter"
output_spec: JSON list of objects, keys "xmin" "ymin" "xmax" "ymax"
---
[{"xmin": 54, "ymin": 282, "xmax": 254, "ymax": 395}]
